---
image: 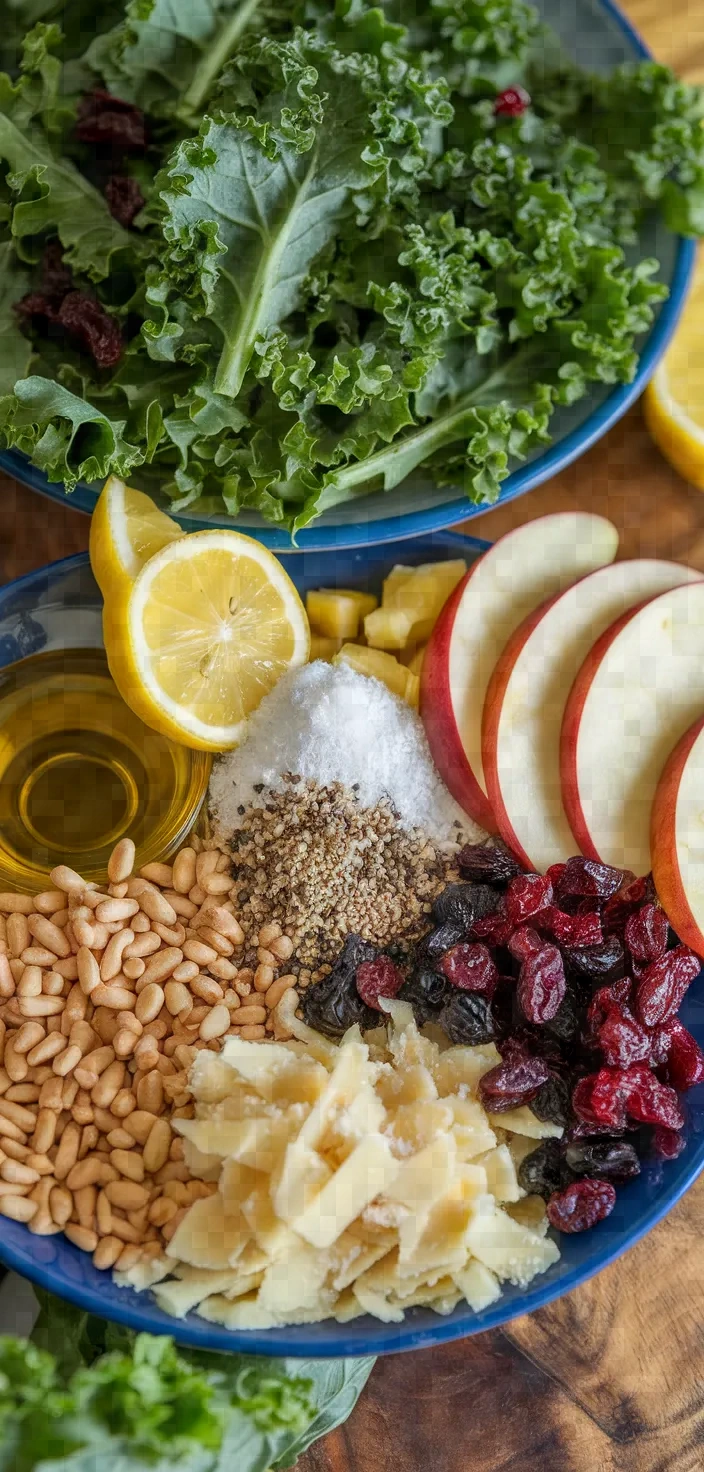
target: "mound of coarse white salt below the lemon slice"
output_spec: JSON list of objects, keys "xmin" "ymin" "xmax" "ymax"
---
[{"xmin": 209, "ymin": 659, "xmax": 485, "ymax": 843}]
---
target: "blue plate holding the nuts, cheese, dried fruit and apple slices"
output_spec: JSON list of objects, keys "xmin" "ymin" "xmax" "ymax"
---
[{"xmin": 0, "ymin": 533, "xmax": 704, "ymax": 1359}]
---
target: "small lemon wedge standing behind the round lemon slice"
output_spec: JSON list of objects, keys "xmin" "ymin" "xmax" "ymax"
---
[{"xmin": 88, "ymin": 475, "xmax": 184, "ymax": 598}]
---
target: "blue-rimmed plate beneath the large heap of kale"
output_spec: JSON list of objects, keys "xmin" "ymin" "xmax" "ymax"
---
[{"xmin": 0, "ymin": 0, "xmax": 695, "ymax": 551}]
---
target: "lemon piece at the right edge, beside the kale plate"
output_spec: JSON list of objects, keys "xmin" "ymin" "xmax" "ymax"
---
[{"xmin": 644, "ymin": 252, "xmax": 704, "ymax": 490}]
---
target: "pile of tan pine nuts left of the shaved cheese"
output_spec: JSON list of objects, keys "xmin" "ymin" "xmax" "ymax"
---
[{"xmin": 0, "ymin": 839, "xmax": 296, "ymax": 1272}]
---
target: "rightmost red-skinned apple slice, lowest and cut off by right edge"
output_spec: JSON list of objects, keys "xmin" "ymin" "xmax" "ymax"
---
[{"xmin": 651, "ymin": 720, "xmax": 704, "ymax": 957}]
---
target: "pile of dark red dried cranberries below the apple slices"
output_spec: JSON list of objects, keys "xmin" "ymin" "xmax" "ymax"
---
[{"xmin": 302, "ymin": 843, "xmax": 704, "ymax": 1232}]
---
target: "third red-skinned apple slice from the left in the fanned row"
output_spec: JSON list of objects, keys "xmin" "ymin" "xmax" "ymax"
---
[{"xmin": 560, "ymin": 581, "xmax": 704, "ymax": 874}]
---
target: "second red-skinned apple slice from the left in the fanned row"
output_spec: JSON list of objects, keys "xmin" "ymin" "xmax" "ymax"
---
[{"xmin": 482, "ymin": 558, "xmax": 701, "ymax": 873}]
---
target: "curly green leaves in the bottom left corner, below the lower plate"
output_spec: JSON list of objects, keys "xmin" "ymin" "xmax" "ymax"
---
[{"xmin": 0, "ymin": 1292, "xmax": 374, "ymax": 1472}]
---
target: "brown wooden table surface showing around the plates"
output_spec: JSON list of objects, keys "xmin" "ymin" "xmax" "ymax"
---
[{"xmin": 0, "ymin": 0, "xmax": 704, "ymax": 1472}]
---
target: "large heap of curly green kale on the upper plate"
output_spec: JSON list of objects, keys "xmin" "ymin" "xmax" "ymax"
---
[{"xmin": 0, "ymin": 0, "xmax": 704, "ymax": 534}]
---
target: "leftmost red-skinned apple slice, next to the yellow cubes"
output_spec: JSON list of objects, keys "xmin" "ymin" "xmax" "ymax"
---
[{"xmin": 421, "ymin": 511, "xmax": 619, "ymax": 833}]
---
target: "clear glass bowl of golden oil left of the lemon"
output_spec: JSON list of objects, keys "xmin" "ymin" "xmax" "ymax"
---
[{"xmin": 0, "ymin": 555, "xmax": 211, "ymax": 892}]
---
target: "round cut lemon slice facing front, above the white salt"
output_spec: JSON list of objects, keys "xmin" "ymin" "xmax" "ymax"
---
[{"xmin": 105, "ymin": 530, "xmax": 311, "ymax": 751}]
